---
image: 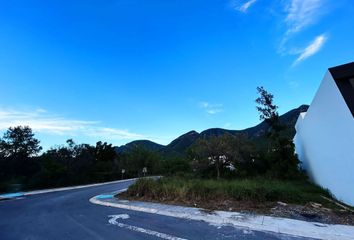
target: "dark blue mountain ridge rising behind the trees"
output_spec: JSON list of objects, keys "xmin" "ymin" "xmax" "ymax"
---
[{"xmin": 115, "ymin": 105, "xmax": 309, "ymax": 156}]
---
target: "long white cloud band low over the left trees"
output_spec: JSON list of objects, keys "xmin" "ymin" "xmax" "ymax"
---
[{"xmin": 0, "ymin": 109, "xmax": 144, "ymax": 140}]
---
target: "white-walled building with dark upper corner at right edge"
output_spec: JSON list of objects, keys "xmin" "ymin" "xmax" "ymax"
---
[{"xmin": 294, "ymin": 62, "xmax": 354, "ymax": 206}]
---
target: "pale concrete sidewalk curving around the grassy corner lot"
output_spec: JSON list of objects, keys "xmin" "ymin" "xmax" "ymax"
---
[{"xmin": 90, "ymin": 190, "xmax": 354, "ymax": 240}]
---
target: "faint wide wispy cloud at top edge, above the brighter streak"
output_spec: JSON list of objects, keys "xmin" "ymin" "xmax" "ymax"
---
[{"xmin": 285, "ymin": 0, "xmax": 323, "ymax": 35}]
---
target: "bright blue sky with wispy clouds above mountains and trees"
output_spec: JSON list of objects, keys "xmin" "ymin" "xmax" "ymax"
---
[{"xmin": 0, "ymin": 0, "xmax": 354, "ymax": 148}]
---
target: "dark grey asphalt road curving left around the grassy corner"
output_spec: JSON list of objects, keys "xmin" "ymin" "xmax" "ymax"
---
[{"xmin": 0, "ymin": 181, "xmax": 314, "ymax": 240}]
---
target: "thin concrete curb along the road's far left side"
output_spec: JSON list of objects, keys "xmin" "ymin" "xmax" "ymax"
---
[{"xmin": 0, "ymin": 178, "xmax": 138, "ymax": 201}]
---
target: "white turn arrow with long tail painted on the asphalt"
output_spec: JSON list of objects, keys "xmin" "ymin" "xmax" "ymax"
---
[{"xmin": 108, "ymin": 214, "xmax": 187, "ymax": 240}]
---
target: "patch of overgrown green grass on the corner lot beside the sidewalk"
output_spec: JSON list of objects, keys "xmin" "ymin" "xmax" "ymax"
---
[{"xmin": 125, "ymin": 177, "xmax": 333, "ymax": 207}]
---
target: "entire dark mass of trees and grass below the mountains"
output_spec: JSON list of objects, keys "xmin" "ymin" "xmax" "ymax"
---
[{"xmin": 0, "ymin": 87, "xmax": 354, "ymax": 225}]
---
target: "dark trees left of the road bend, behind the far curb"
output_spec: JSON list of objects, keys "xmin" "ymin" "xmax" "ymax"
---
[{"xmin": 0, "ymin": 126, "xmax": 167, "ymax": 192}]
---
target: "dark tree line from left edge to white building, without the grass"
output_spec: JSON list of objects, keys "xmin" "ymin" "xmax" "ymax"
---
[{"xmin": 0, "ymin": 87, "xmax": 322, "ymax": 193}]
